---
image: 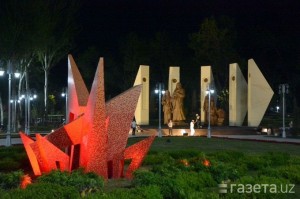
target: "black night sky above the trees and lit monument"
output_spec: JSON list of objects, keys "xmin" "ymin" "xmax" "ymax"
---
[{"xmin": 47, "ymin": 0, "xmax": 300, "ymax": 109}]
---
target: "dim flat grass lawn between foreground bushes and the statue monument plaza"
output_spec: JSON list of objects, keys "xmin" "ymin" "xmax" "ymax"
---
[{"xmin": 128, "ymin": 137, "xmax": 300, "ymax": 156}]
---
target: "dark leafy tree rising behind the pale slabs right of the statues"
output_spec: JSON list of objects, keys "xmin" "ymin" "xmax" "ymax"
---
[{"xmin": 189, "ymin": 17, "xmax": 240, "ymax": 89}]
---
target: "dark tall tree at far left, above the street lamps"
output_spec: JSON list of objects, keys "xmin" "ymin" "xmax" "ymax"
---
[{"xmin": 0, "ymin": 0, "xmax": 35, "ymax": 127}]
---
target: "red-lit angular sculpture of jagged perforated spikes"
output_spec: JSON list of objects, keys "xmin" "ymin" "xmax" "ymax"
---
[{"xmin": 20, "ymin": 55, "xmax": 155, "ymax": 179}]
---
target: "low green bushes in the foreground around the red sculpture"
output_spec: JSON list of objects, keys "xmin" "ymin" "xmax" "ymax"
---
[{"xmin": 0, "ymin": 150, "xmax": 300, "ymax": 199}]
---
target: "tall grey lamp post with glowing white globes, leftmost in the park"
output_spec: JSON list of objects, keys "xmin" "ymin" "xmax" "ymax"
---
[{"xmin": 0, "ymin": 61, "xmax": 20, "ymax": 146}]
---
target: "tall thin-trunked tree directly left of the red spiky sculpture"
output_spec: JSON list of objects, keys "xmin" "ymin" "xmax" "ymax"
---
[{"xmin": 34, "ymin": 0, "xmax": 78, "ymax": 116}]
